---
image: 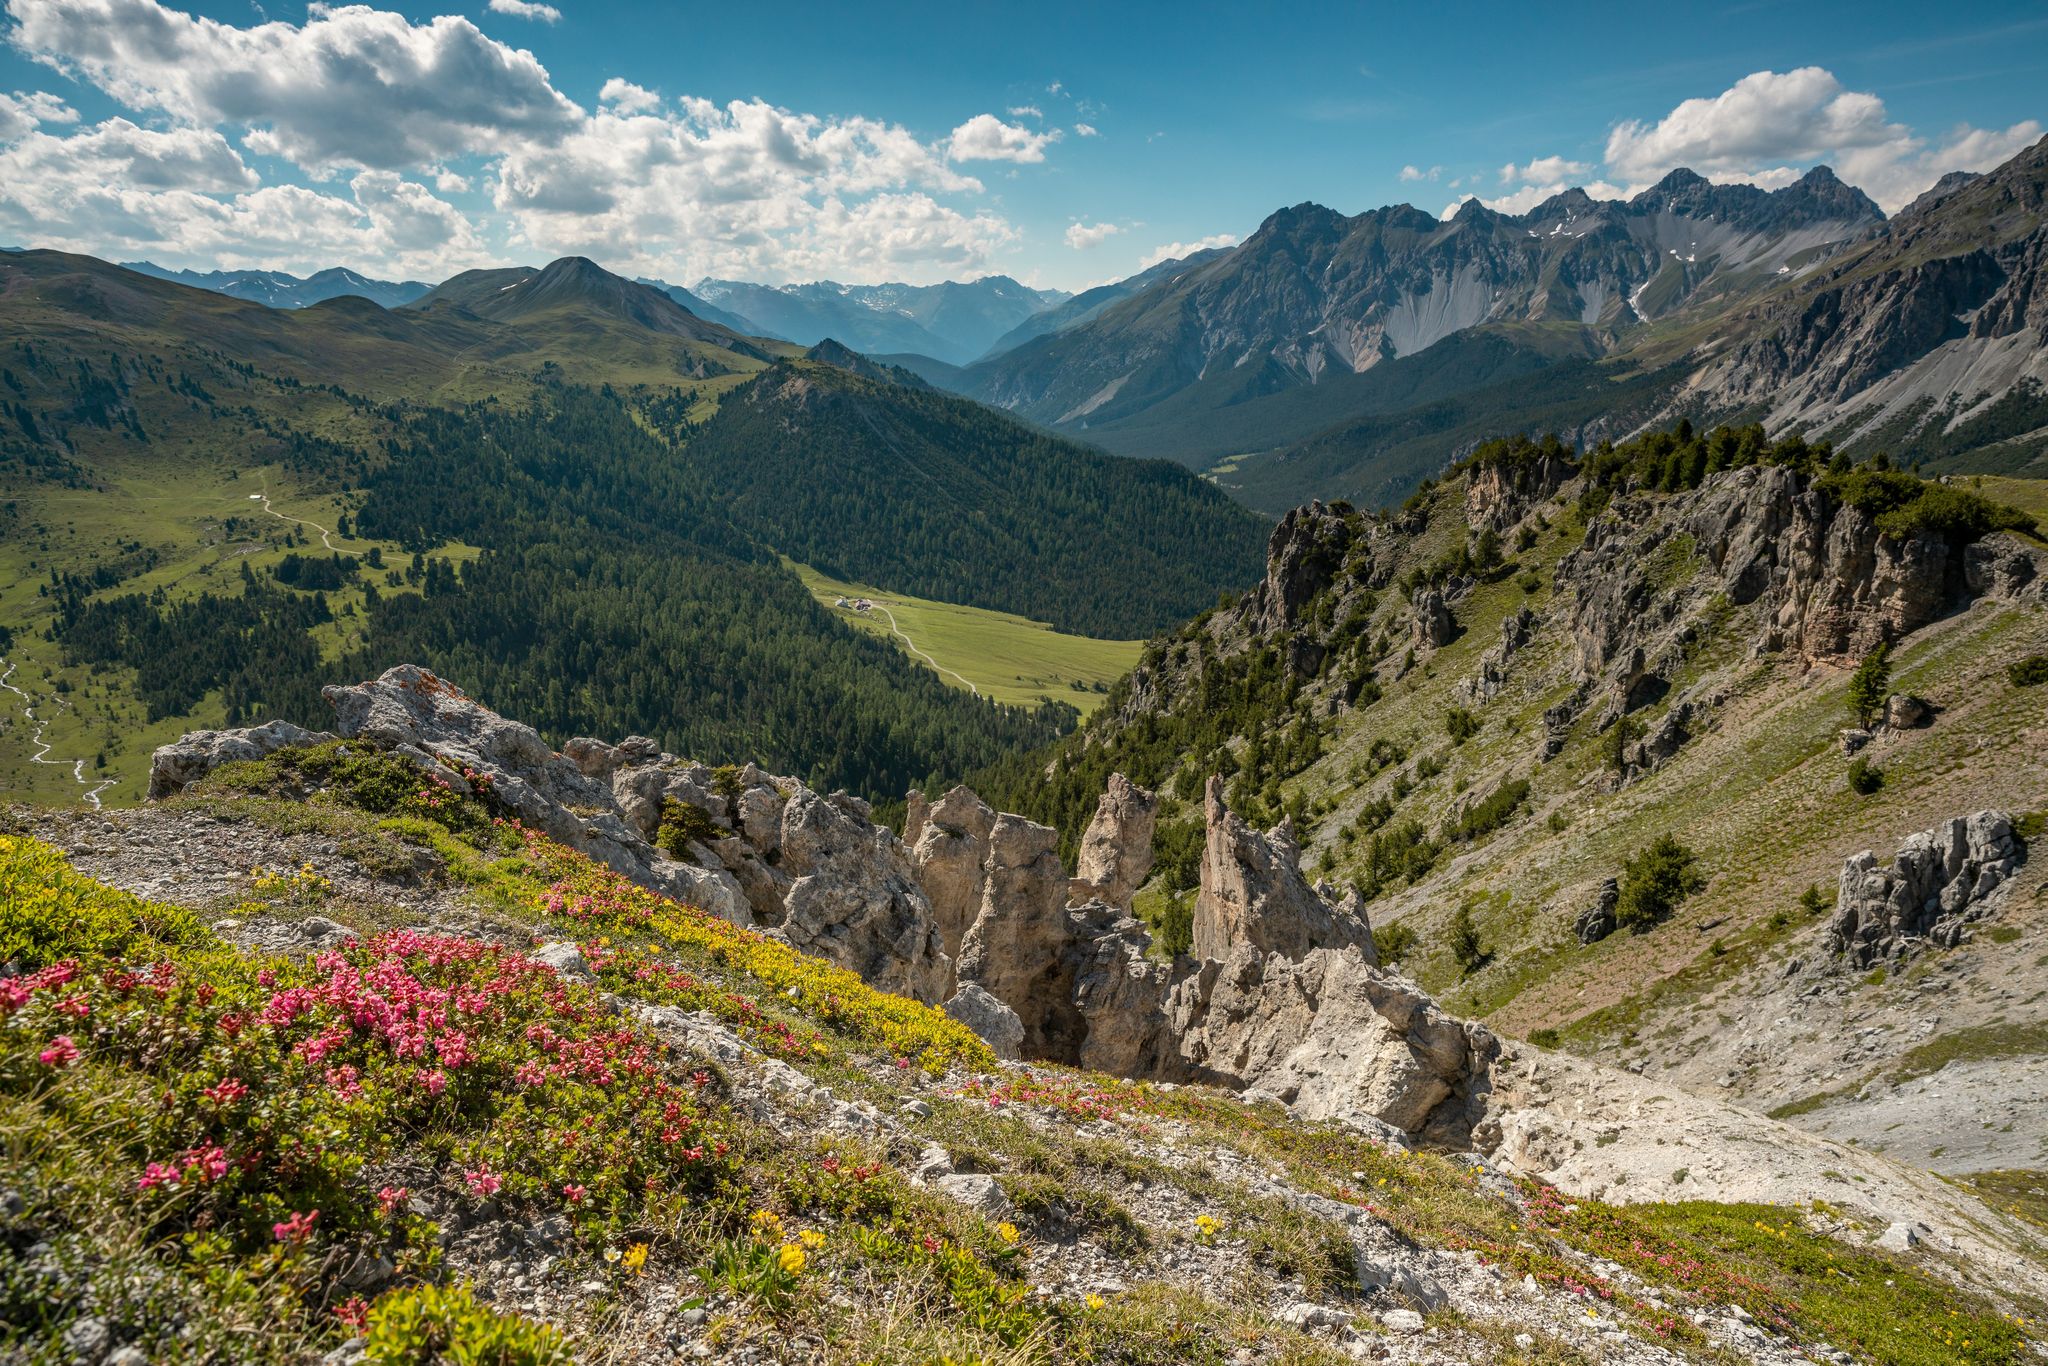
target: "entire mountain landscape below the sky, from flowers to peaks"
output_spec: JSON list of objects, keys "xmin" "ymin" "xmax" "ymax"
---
[{"xmin": 0, "ymin": 117, "xmax": 2048, "ymax": 1366}]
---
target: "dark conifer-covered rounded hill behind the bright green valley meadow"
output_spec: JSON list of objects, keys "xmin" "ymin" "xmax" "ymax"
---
[{"xmin": 686, "ymin": 362, "xmax": 1266, "ymax": 639}]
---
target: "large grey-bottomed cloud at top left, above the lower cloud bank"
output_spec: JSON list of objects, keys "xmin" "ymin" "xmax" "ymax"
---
[{"xmin": 8, "ymin": 0, "xmax": 582, "ymax": 172}]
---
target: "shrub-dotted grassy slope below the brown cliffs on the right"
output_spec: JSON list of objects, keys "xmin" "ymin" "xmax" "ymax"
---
[{"xmin": 1228, "ymin": 483, "xmax": 2048, "ymax": 1047}]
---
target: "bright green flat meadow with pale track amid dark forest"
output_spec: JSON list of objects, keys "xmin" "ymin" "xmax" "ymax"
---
[{"xmin": 791, "ymin": 563, "xmax": 1145, "ymax": 715}]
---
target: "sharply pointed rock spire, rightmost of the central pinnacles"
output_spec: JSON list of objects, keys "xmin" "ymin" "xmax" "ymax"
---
[{"xmin": 1194, "ymin": 778, "xmax": 1380, "ymax": 963}]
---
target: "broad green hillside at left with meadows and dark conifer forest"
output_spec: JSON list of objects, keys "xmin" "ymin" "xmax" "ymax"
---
[{"xmin": 0, "ymin": 252, "xmax": 1228, "ymax": 801}]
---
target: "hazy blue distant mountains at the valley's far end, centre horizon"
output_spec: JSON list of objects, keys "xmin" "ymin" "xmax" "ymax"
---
[{"xmin": 690, "ymin": 274, "xmax": 1067, "ymax": 365}]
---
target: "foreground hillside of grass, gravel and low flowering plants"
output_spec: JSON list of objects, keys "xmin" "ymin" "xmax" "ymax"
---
[{"xmin": 0, "ymin": 756, "xmax": 2036, "ymax": 1366}]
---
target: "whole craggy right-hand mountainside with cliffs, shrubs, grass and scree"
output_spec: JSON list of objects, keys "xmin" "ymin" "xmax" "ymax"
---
[{"xmin": 977, "ymin": 428, "xmax": 2048, "ymax": 1171}]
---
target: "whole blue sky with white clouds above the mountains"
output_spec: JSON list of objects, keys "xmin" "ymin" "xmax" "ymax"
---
[{"xmin": 0, "ymin": 0, "xmax": 2048, "ymax": 289}]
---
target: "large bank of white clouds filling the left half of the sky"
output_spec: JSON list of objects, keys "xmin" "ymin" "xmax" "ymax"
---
[{"xmin": 0, "ymin": 0, "xmax": 1061, "ymax": 283}]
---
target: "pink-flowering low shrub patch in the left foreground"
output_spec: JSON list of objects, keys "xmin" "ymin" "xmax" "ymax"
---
[{"xmin": 0, "ymin": 838, "xmax": 733, "ymax": 1343}]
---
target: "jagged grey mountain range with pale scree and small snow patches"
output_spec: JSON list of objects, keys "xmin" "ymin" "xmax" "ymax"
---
[{"xmin": 969, "ymin": 168, "xmax": 1884, "ymax": 428}]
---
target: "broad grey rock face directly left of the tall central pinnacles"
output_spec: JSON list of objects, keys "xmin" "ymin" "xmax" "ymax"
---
[{"xmin": 780, "ymin": 788, "xmax": 952, "ymax": 1001}]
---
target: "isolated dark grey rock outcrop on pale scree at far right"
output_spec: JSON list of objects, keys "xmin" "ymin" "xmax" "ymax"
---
[{"xmin": 1825, "ymin": 811, "xmax": 2028, "ymax": 969}]
